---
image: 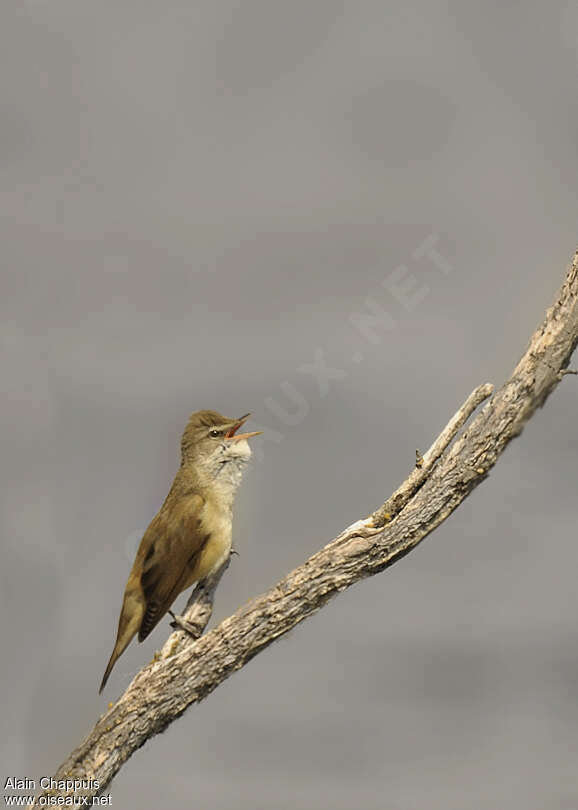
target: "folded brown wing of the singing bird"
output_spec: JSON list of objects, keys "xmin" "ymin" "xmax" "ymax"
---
[{"xmin": 138, "ymin": 494, "xmax": 208, "ymax": 641}]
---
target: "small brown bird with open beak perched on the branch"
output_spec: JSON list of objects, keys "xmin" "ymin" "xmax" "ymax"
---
[{"xmin": 99, "ymin": 411, "xmax": 261, "ymax": 692}]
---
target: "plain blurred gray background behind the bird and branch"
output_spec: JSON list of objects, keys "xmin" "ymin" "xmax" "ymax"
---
[{"xmin": 0, "ymin": 0, "xmax": 578, "ymax": 810}]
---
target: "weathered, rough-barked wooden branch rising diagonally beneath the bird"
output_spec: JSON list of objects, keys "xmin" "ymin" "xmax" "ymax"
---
[{"xmin": 28, "ymin": 254, "xmax": 578, "ymax": 796}]
